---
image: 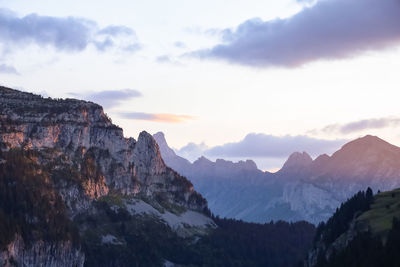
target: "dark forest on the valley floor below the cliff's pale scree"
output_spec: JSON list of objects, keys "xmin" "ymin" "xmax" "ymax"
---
[{"xmin": 82, "ymin": 197, "xmax": 315, "ymax": 267}]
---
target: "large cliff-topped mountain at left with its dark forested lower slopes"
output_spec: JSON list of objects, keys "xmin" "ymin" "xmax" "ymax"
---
[{"xmin": 0, "ymin": 87, "xmax": 315, "ymax": 267}]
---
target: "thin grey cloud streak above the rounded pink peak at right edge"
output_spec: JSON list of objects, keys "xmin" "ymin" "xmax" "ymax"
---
[{"xmin": 321, "ymin": 117, "xmax": 400, "ymax": 134}]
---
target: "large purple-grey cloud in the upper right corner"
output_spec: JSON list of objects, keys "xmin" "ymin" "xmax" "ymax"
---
[{"xmin": 188, "ymin": 0, "xmax": 400, "ymax": 67}]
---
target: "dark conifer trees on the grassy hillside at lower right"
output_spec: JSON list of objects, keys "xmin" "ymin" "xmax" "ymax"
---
[{"xmin": 314, "ymin": 188, "xmax": 400, "ymax": 267}]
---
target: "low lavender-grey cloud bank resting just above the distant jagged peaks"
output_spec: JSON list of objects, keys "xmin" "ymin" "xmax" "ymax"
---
[{"xmin": 205, "ymin": 133, "xmax": 347, "ymax": 158}]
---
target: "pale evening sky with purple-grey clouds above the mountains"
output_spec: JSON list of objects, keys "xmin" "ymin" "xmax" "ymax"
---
[{"xmin": 0, "ymin": 0, "xmax": 400, "ymax": 170}]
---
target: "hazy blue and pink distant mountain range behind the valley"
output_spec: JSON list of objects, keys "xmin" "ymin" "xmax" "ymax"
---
[{"xmin": 155, "ymin": 134, "xmax": 400, "ymax": 224}]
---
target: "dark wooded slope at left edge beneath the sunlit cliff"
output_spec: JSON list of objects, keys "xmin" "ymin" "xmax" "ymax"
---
[{"xmin": 0, "ymin": 149, "xmax": 79, "ymax": 250}]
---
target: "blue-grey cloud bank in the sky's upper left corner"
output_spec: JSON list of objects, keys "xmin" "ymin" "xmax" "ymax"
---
[{"xmin": 0, "ymin": 9, "xmax": 141, "ymax": 52}]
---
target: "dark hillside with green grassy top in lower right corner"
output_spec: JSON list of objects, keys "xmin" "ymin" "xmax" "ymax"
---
[{"xmin": 305, "ymin": 189, "xmax": 400, "ymax": 267}]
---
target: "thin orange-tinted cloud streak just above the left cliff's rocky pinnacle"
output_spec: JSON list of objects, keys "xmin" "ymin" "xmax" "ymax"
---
[{"xmin": 119, "ymin": 112, "xmax": 195, "ymax": 123}]
